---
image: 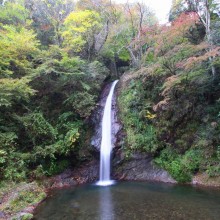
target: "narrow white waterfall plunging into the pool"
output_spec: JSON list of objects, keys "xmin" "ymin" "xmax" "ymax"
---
[{"xmin": 97, "ymin": 80, "xmax": 118, "ymax": 186}]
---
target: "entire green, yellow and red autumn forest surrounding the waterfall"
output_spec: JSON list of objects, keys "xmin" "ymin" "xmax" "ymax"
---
[{"xmin": 0, "ymin": 0, "xmax": 220, "ymax": 182}]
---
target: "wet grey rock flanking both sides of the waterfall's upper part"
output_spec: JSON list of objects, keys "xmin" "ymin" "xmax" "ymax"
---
[{"xmin": 91, "ymin": 83, "xmax": 121, "ymax": 150}]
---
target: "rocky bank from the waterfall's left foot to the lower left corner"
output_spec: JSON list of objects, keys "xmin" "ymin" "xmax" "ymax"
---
[{"xmin": 0, "ymin": 160, "xmax": 99, "ymax": 220}]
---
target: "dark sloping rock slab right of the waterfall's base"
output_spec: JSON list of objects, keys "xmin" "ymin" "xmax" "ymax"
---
[{"xmin": 114, "ymin": 153, "xmax": 176, "ymax": 183}]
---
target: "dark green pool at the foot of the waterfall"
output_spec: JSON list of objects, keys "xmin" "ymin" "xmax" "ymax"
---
[{"xmin": 35, "ymin": 182, "xmax": 220, "ymax": 220}]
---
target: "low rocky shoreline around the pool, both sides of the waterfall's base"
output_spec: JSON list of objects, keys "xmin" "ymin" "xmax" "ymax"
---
[{"xmin": 0, "ymin": 157, "xmax": 220, "ymax": 220}]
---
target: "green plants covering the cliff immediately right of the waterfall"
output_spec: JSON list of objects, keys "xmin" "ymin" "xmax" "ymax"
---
[{"xmin": 118, "ymin": 81, "xmax": 160, "ymax": 155}]
